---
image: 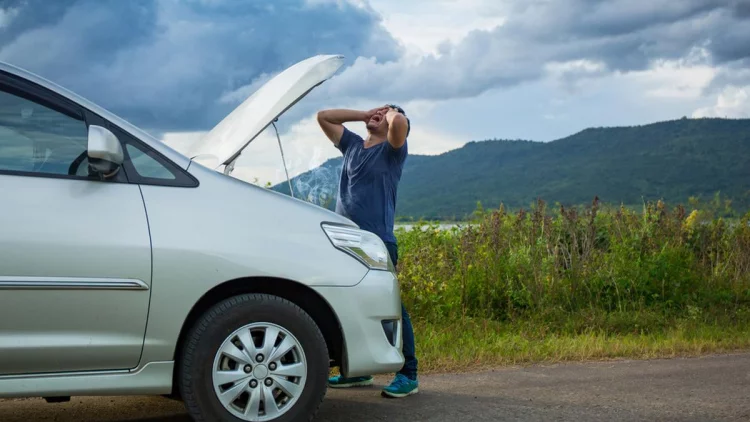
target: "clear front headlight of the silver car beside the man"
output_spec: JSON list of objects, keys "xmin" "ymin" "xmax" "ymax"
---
[{"xmin": 323, "ymin": 224, "xmax": 393, "ymax": 271}]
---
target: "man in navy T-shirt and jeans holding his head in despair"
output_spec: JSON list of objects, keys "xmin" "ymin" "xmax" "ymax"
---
[{"xmin": 318, "ymin": 105, "xmax": 419, "ymax": 397}]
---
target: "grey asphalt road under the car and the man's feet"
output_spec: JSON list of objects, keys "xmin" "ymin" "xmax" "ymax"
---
[{"xmin": 0, "ymin": 354, "xmax": 750, "ymax": 422}]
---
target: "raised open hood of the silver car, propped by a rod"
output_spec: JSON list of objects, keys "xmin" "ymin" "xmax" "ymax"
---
[{"xmin": 188, "ymin": 55, "xmax": 344, "ymax": 169}]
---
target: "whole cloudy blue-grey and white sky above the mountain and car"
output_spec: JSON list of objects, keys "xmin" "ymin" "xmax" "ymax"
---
[{"xmin": 0, "ymin": 0, "xmax": 750, "ymax": 183}]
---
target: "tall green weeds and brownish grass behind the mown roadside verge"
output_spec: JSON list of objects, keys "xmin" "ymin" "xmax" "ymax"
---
[{"xmin": 397, "ymin": 199, "xmax": 750, "ymax": 336}]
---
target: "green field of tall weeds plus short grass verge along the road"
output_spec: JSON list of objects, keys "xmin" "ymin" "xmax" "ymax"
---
[{"xmin": 397, "ymin": 200, "xmax": 750, "ymax": 372}]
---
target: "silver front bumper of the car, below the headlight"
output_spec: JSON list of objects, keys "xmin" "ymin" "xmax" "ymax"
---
[{"xmin": 316, "ymin": 271, "xmax": 404, "ymax": 377}]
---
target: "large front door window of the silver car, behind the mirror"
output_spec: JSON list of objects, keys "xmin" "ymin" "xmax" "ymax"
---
[{"xmin": 0, "ymin": 87, "xmax": 88, "ymax": 178}]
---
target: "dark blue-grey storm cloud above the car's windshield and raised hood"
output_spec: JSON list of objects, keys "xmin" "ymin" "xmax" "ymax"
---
[{"xmin": 0, "ymin": 0, "xmax": 400, "ymax": 131}]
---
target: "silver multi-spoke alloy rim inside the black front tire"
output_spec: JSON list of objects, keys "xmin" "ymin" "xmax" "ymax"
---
[{"xmin": 211, "ymin": 322, "xmax": 307, "ymax": 421}]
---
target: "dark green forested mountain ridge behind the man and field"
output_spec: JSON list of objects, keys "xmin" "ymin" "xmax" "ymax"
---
[{"xmin": 274, "ymin": 118, "xmax": 750, "ymax": 219}]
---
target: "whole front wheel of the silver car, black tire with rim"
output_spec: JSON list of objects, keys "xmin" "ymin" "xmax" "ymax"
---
[{"xmin": 178, "ymin": 294, "xmax": 329, "ymax": 422}]
